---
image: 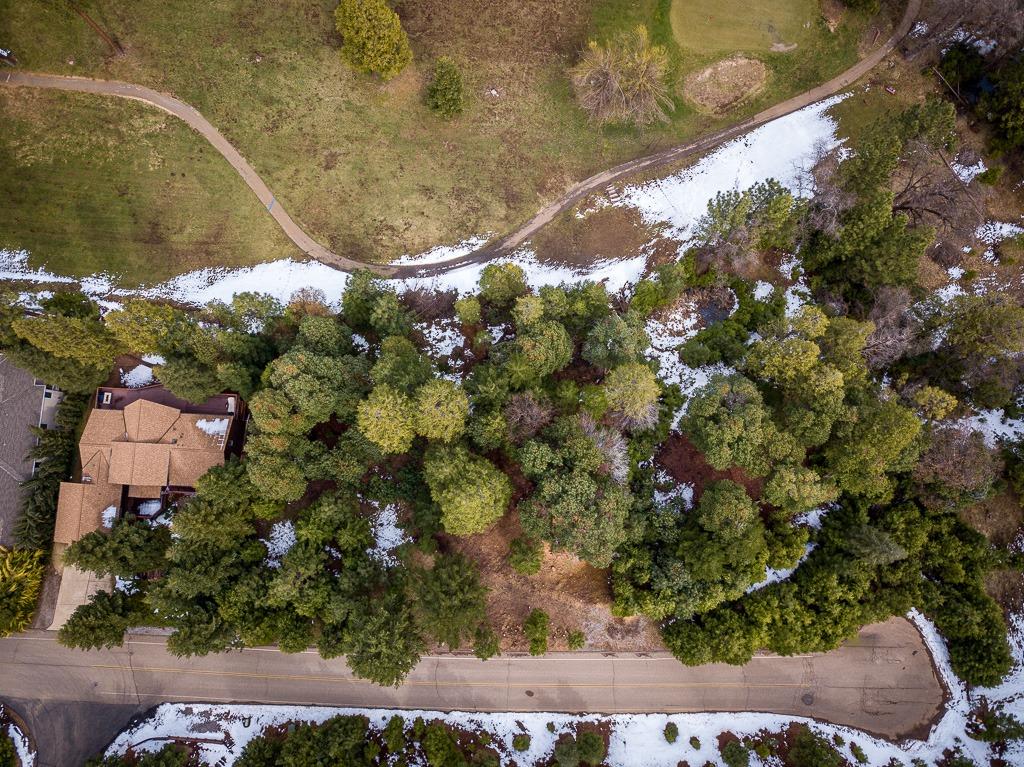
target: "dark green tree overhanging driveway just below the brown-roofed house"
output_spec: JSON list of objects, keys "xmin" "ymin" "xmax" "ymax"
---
[{"xmin": 61, "ymin": 519, "xmax": 171, "ymax": 578}]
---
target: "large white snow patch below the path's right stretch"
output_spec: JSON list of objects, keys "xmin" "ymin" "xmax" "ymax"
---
[{"xmin": 621, "ymin": 95, "xmax": 846, "ymax": 242}]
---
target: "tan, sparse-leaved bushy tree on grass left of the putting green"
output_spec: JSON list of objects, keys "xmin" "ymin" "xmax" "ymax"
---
[{"xmin": 570, "ymin": 27, "xmax": 673, "ymax": 125}]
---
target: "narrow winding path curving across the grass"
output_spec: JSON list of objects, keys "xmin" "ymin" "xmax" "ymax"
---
[{"xmin": 0, "ymin": 0, "xmax": 922, "ymax": 278}]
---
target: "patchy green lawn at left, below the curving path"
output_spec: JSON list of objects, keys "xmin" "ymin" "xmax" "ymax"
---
[{"xmin": 0, "ymin": 89, "xmax": 300, "ymax": 285}]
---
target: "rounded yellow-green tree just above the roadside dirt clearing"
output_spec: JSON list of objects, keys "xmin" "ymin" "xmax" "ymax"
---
[{"xmin": 423, "ymin": 444, "xmax": 512, "ymax": 536}]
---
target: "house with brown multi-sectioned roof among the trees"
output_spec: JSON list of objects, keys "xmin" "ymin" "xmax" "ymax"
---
[{"xmin": 50, "ymin": 384, "xmax": 245, "ymax": 629}]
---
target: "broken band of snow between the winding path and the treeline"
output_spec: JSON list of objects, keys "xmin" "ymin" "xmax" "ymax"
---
[{"xmin": 0, "ymin": 96, "xmax": 842, "ymax": 305}]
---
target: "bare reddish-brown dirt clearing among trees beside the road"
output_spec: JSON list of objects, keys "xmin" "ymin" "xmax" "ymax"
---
[{"xmin": 441, "ymin": 512, "xmax": 664, "ymax": 652}]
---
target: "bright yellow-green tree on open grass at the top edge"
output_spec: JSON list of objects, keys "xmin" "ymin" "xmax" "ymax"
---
[{"xmin": 334, "ymin": 0, "xmax": 413, "ymax": 80}]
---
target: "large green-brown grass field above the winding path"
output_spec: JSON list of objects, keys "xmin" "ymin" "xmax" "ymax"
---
[{"xmin": 0, "ymin": 0, "xmax": 880, "ymax": 280}]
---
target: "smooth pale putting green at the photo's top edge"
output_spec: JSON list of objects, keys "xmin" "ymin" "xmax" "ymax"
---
[{"xmin": 672, "ymin": 0, "xmax": 827, "ymax": 53}]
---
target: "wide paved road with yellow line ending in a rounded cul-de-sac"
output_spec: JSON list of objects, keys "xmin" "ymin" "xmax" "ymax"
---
[{"xmin": 0, "ymin": 619, "xmax": 943, "ymax": 767}]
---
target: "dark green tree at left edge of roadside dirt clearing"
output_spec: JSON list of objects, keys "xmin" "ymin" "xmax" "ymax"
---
[{"xmin": 416, "ymin": 554, "xmax": 487, "ymax": 650}]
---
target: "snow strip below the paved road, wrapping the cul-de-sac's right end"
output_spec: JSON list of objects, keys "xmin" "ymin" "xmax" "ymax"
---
[{"xmin": 99, "ymin": 610, "xmax": 1024, "ymax": 767}]
